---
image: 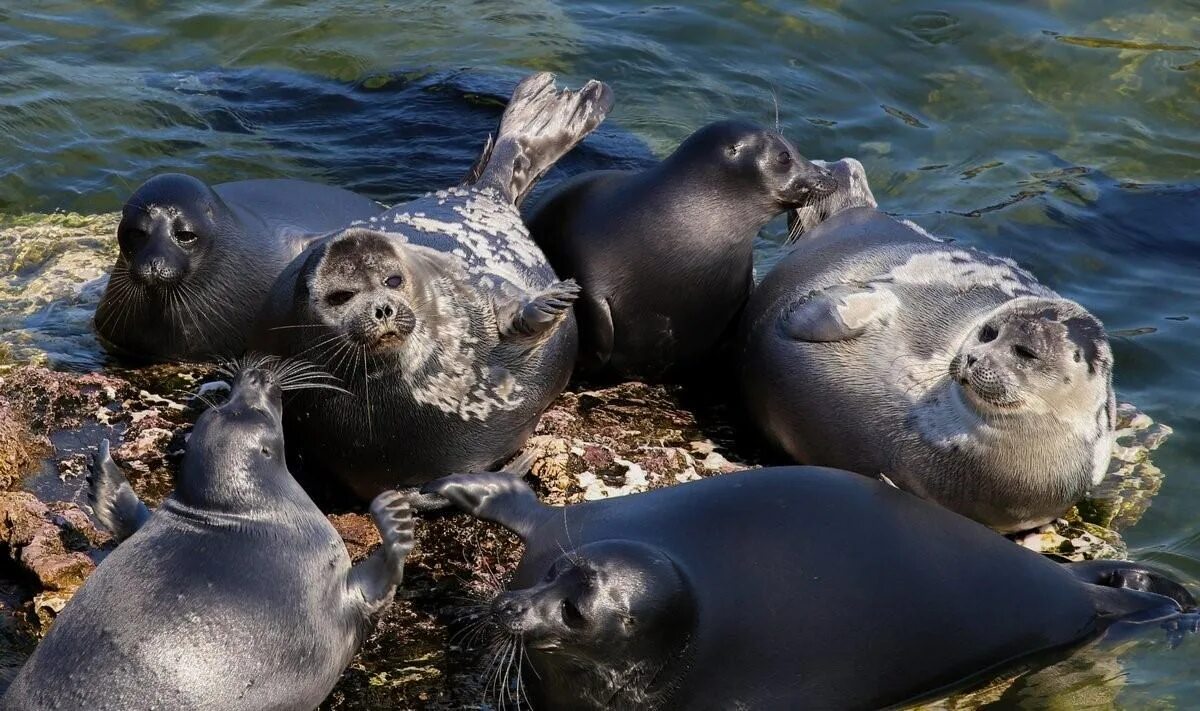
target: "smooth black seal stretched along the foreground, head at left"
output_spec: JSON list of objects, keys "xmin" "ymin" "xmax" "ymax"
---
[{"xmin": 425, "ymin": 467, "xmax": 1194, "ymax": 710}]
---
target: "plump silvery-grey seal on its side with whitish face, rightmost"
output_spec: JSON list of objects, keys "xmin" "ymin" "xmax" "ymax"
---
[{"xmin": 739, "ymin": 202, "xmax": 1115, "ymax": 531}]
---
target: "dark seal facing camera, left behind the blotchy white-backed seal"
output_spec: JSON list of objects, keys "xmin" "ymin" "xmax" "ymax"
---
[{"xmin": 94, "ymin": 173, "xmax": 383, "ymax": 360}]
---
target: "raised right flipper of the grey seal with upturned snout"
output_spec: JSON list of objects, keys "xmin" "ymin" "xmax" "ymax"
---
[{"xmin": 347, "ymin": 491, "xmax": 414, "ymax": 617}]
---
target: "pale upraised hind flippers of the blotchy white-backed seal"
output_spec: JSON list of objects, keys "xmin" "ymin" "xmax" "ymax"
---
[{"xmin": 467, "ymin": 72, "xmax": 612, "ymax": 205}]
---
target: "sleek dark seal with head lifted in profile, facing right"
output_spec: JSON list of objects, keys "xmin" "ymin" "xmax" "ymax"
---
[{"xmin": 528, "ymin": 121, "xmax": 835, "ymax": 380}]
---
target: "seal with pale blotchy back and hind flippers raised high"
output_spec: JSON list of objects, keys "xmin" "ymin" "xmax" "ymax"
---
[{"xmin": 253, "ymin": 73, "xmax": 612, "ymax": 500}]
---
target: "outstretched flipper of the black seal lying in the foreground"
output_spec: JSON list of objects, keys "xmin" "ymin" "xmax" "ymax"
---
[{"xmin": 421, "ymin": 453, "xmax": 551, "ymax": 538}]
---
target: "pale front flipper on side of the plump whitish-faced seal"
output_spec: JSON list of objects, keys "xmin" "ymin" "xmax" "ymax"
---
[{"xmin": 780, "ymin": 283, "xmax": 896, "ymax": 343}]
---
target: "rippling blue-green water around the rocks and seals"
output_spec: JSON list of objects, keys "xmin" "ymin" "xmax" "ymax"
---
[{"xmin": 0, "ymin": 0, "xmax": 1200, "ymax": 709}]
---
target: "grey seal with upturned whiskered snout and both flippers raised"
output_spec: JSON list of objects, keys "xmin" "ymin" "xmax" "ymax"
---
[{"xmin": 0, "ymin": 366, "xmax": 413, "ymax": 711}]
